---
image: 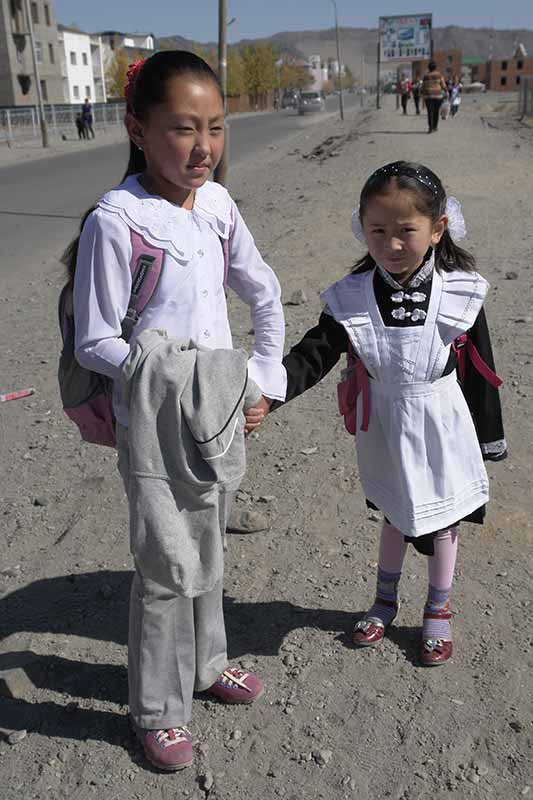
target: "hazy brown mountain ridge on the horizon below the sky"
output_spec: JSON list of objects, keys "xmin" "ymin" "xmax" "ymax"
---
[{"xmin": 159, "ymin": 25, "xmax": 533, "ymax": 80}]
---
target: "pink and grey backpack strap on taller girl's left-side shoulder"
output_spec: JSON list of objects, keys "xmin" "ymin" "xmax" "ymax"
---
[{"xmin": 122, "ymin": 228, "xmax": 165, "ymax": 342}]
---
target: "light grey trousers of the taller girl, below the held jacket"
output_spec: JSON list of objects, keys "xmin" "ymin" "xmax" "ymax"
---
[{"xmin": 117, "ymin": 426, "xmax": 235, "ymax": 729}]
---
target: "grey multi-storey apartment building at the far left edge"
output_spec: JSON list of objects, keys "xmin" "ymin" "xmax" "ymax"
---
[{"xmin": 0, "ymin": 0, "xmax": 63, "ymax": 106}]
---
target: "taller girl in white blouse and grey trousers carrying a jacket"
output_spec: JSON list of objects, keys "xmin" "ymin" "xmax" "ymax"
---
[{"xmin": 65, "ymin": 50, "xmax": 286, "ymax": 770}]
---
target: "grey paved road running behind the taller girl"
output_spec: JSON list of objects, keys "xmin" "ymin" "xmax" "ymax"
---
[{"xmin": 0, "ymin": 95, "xmax": 358, "ymax": 292}]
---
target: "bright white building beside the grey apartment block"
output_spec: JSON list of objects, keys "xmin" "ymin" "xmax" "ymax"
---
[{"xmin": 57, "ymin": 25, "xmax": 107, "ymax": 103}]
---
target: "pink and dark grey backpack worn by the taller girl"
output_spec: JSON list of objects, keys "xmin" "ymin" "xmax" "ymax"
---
[{"xmin": 58, "ymin": 229, "xmax": 229, "ymax": 447}]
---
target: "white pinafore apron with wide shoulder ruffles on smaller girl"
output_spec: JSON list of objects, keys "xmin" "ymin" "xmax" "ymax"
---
[{"xmin": 323, "ymin": 270, "xmax": 489, "ymax": 536}]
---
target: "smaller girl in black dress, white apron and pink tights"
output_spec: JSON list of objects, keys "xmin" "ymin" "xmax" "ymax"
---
[{"xmin": 258, "ymin": 161, "xmax": 507, "ymax": 666}]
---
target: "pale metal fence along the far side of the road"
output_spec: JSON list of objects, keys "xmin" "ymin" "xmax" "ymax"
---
[{"xmin": 0, "ymin": 103, "xmax": 126, "ymax": 145}]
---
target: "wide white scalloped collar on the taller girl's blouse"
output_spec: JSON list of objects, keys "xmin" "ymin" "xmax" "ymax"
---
[{"xmin": 98, "ymin": 175, "xmax": 232, "ymax": 262}]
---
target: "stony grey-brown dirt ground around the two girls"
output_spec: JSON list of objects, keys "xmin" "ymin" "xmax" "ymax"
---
[{"xmin": 0, "ymin": 98, "xmax": 533, "ymax": 800}]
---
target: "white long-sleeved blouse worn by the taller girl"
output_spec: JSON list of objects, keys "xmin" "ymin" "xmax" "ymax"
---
[{"xmin": 74, "ymin": 175, "xmax": 287, "ymax": 425}]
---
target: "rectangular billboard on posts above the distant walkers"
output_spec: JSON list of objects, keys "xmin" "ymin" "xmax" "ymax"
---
[{"xmin": 379, "ymin": 14, "xmax": 431, "ymax": 62}]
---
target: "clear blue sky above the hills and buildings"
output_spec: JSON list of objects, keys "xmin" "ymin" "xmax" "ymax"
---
[{"xmin": 56, "ymin": 0, "xmax": 533, "ymax": 42}]
